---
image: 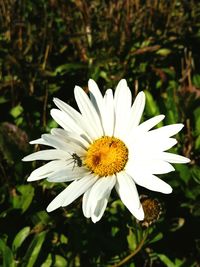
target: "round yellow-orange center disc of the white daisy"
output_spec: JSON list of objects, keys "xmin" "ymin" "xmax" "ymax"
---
[{"xmin": 85, "ymin": 136, "xmax": 128, "ymax": 177}]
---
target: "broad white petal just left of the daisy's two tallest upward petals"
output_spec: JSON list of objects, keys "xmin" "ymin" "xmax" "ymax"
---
[{"xmin": 74, "ymin": 86, "xmax": 103, "ymax": 138}]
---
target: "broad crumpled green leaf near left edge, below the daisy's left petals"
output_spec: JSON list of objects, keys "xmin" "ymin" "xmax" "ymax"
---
[{"xmin": 12, "ymin": 184, "xmax": 34, "ymax": 212}]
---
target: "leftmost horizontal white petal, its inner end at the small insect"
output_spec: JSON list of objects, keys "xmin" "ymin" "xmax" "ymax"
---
[{"xmin": 22, "ymin": 149, "xmax": 69, "ymax": 161}]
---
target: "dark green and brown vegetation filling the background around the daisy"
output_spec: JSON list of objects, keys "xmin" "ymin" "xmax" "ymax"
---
[{"xmin": 0, "ymin": 0, "xmax": 200, "ymax": 267}]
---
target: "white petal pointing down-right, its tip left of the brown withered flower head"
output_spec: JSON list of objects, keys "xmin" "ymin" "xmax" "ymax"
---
[{"xmin": 116, "ymin": 172, "xmax": 144, "ymax": 220}]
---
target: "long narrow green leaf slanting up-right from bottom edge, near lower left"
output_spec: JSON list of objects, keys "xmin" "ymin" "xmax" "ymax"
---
[{"xmin": 22, "ymin": 231, "xmax": 47, "ymax": 267}]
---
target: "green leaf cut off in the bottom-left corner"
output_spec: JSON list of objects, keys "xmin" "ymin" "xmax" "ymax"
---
[{"xmin": 0, "ymin": 239, "xmax": 16, "ymax": 267}]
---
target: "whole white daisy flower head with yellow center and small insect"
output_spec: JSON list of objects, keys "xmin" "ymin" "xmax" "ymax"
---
[{"xmin": 23, "ymin": 79, "xmax": 189, "ymax": 223}]
